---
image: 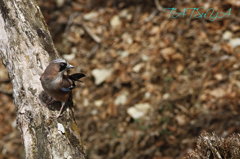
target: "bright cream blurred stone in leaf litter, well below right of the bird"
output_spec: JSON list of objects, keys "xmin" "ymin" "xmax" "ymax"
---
[{"xmin": 127, "ymin": 103, "xmax": 151, "ymax": 119}]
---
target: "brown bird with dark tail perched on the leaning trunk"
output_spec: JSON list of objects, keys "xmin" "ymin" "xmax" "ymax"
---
[{"xmin": 40, "ymin": 58, "xmax": 85, "ymax": 117}]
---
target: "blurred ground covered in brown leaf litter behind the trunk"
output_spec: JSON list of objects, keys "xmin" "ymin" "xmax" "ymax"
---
[{"xmin": 0, "ymin": 0, "xmax": 240, "ymax": 159}]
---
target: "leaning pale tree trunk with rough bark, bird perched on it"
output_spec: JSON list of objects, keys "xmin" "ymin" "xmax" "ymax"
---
[{"xmin": 0, "ymin": 0, "xmax": 84, "ymax": 159}]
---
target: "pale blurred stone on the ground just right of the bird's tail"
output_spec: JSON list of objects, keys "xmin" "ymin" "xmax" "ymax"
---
[{"xmin": 92, "ymin": 69, "xmax": 112, "ymax": 85}]
